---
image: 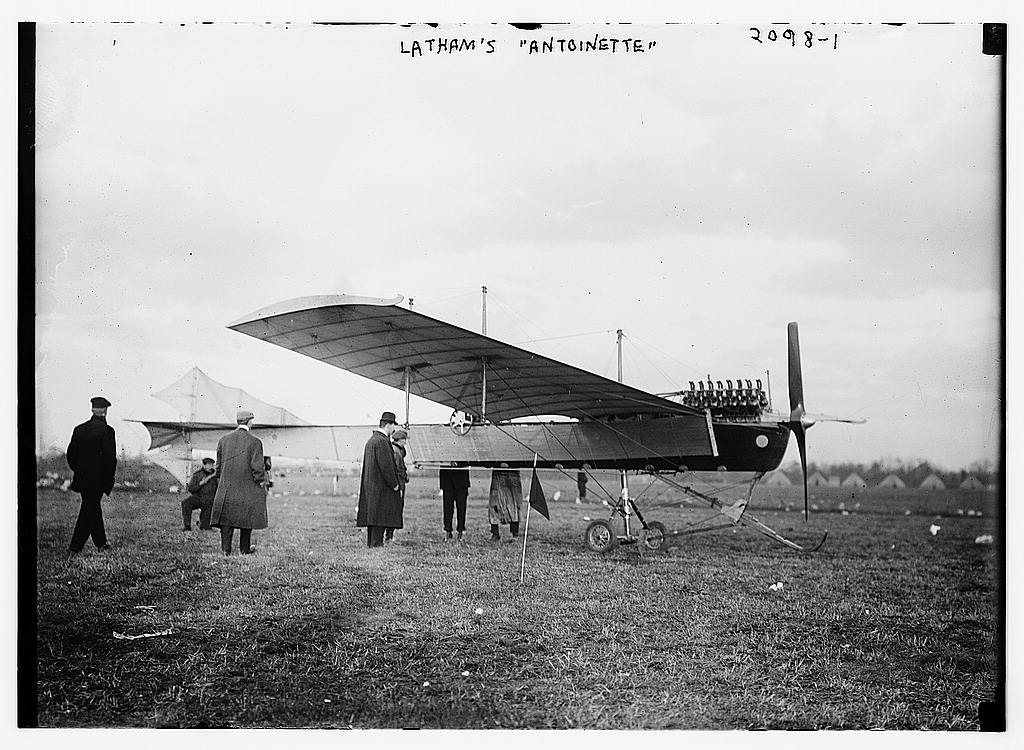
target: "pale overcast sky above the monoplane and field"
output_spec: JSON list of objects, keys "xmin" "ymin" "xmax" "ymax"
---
[{"xmin": 36, "ymin": 24, "xmax": 1001, "ymax": 468}]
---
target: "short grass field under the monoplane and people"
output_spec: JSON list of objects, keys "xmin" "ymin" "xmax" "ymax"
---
[{"xmin": 37, "ymin": 472, "xmax": 1001, "ymax": 730}]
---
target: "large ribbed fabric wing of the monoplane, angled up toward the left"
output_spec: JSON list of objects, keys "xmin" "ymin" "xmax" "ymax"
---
[{"xmin": 228, "ymin": 295, "xmax": 702, "ymax": 421}]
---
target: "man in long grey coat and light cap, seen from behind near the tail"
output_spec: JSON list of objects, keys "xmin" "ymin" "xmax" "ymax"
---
[{"xmin": 210, "ymin": 409, "xmax": 267, "ymax": 554}]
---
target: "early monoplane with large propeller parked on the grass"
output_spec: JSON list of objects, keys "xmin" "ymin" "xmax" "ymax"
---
[{"xmin": 132, "ymin": 295, "xmax": 862, "ymax": 551}]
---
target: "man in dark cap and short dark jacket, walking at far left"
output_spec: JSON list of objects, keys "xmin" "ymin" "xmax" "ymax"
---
[{"xmin": 66, "ymin": 395, "xmax": 118, "ymax": 554}]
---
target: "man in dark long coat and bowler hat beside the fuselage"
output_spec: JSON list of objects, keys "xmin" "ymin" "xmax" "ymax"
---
[{"xmin": 355, "ymin": 412, "xmax": 401, "ymax": 547}]
